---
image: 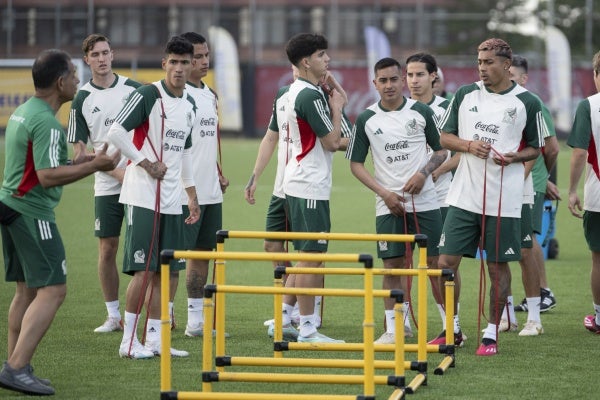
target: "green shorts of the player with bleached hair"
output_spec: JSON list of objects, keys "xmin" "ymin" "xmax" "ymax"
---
[{"xmin": 440, "ymin": 206, "xmax": 521, "ymax": 262}]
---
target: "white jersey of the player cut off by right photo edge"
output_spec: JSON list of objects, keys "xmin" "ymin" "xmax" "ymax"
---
[{"xmin": 567, "ymin": 93, "xmax": 600, "ymax": 212}]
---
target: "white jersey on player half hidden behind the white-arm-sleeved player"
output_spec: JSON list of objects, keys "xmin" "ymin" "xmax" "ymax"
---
[{"xmin": 181, "ymin": 83, "xmax": 223, "ymax": 205}]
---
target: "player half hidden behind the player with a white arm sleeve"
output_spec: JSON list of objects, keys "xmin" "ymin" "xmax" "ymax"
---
[{"xmin": 177, "ymin": 32, "xmax": 229, "ymax": 337}]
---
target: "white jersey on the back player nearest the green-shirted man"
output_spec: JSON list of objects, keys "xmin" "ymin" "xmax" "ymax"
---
[{"xmin": 67, "ymin": 74, "xmax": 141, "ymax": 196}]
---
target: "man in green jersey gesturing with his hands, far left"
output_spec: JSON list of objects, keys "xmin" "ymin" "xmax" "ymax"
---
[{"xmin": 0, "ymin": 50, "xmax": 121, "ymax": 395}]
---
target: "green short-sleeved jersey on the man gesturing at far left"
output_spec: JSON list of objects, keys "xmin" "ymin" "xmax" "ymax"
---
[{"xmin": 0, "ymin": 97, "xmax": 68, "ymax": 222}]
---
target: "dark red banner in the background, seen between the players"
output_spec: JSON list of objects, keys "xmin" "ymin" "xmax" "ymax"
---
[{"xmin": 254, "ymin": 66, "xmax": 596, "ymax": 132}]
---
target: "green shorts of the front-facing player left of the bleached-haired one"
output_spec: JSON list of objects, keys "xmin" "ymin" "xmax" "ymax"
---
[{"xmin": 375, "ymin": 210, "xmax": 442, "ymax": 259}]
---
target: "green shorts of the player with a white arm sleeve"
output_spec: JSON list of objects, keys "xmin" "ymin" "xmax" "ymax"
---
[{"xmin": 123, "ymin": 205, "xmax": 185, "ymax": 275}]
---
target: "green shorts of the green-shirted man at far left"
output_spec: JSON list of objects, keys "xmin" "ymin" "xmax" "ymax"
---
[{"xmin": 0, "ymin": 215, "xmax": 67, "ymax": 288}]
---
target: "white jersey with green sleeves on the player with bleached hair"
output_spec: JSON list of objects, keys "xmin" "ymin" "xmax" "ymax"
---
[{"xmin": 440, "ymin": 81, "xmax": 546, "ymax": 218}]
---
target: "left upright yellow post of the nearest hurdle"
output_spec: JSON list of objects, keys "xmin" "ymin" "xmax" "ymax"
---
[{"xmin": 160, "ymin": 261, "xmax": 171, "ymax": 392}]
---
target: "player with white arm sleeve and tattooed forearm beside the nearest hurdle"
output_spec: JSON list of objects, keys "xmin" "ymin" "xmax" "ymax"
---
[{"xmin": 108, "ymin": 36, "xmax": 200, "ymax": 359}]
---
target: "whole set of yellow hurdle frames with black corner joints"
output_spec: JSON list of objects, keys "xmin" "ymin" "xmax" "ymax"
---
[{"xmin": 160, "ymin": 231, "xmax": 455, "ymax": 400}]
